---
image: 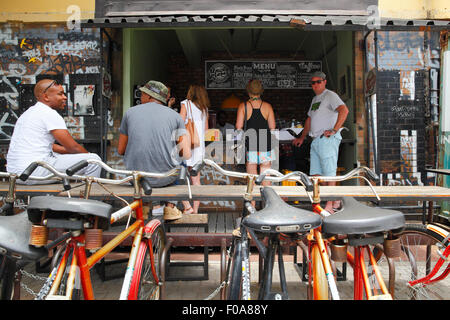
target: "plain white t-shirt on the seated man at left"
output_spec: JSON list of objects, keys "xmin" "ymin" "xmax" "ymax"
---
[{"xmin": 6, "ymin": 102, "xmax": 67, "ymax": 174}]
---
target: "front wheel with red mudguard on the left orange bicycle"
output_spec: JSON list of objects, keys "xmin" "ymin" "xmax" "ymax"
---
[{"xmin": 128, "ymin": 225, "xmax": 166, "ymax": 300}]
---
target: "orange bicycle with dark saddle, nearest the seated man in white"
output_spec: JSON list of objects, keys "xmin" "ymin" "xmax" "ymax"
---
[{"xmin": 6, "ymin": 160, "xmax": 185, "ymax": 300}]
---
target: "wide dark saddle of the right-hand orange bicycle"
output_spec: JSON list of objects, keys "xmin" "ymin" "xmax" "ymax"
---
[{"xmin": 322, "ymin": 197, "xmax": 405, "ymax": 234}]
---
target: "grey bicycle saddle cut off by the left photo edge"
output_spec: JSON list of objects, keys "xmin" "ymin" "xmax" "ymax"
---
[{"xmin": 0, "ymin": 211, "xmax": 48, "ymax": 261}]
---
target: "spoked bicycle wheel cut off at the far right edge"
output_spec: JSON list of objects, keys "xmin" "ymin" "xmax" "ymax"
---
[{"xmin": 395, "ymin": 224, "xmax": 450, "ymax": 300}]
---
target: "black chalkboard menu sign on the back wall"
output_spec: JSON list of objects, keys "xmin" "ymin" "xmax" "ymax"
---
[{"xmin": 205, "ymin": 60, "xmax": 322, "ymax": 89}]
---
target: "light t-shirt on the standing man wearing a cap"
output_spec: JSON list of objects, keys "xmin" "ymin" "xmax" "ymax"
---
[{"xmin": 308, "ymin": 89, "xmax": 345, "ymax": 138}]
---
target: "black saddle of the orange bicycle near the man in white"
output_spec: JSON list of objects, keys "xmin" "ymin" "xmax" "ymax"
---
[{"xmin": 27, "ymin": 196, "xmax": 113, "ymax": 229}]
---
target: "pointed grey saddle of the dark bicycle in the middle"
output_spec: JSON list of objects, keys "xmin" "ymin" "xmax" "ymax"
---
[{"xmin": 243, "ymin": 187, "xmax": 322, "ymax": 233}]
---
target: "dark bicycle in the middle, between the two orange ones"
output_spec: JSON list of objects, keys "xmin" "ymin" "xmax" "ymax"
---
[{"xmin": 192, "ymin": 159, "xmax": 330, "ymax": 300}]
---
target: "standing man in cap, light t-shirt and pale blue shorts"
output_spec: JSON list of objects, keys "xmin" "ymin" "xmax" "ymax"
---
[{"xmin": 292, "ymin": 71, "xmax": 348, "ymax": 213}]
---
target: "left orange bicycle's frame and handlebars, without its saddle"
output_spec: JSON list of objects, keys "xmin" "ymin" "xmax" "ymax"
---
[{"xmin": 20, "ymin": 160, "xmax": 178, "ymax": 300}]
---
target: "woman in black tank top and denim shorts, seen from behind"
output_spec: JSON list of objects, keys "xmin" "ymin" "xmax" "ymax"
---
[{"xmin": 236, "ymin": 80, "xmax": 275, "ymax": 185}]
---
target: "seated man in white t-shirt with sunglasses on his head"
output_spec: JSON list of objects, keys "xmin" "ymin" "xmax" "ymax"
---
[{"xmin": 6, "ymin": 79, "xmax": 101, "ymax": 184}]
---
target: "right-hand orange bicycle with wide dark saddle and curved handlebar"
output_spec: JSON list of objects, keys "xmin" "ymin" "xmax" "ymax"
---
[{"xmin": 298, "ymin": 167, "xmax": 405, "ymax": 300}]
